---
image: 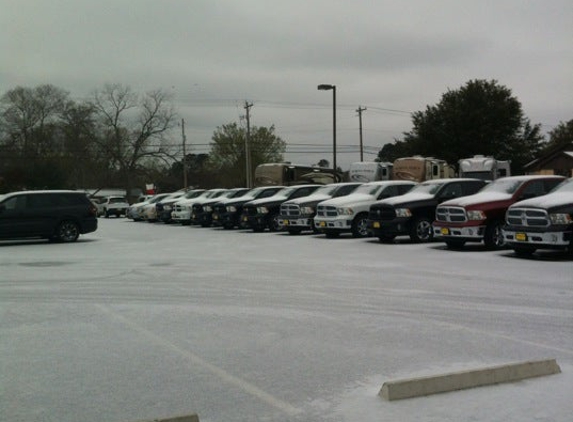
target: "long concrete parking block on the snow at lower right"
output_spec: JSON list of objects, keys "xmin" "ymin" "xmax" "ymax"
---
[{"xmin": 378, "ymin": 359, "xmax": 561, "ymax": 401}]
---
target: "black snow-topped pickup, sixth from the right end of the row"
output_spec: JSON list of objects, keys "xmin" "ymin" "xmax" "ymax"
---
[{"xmin": 243, "ymin": 184, "xmax": 324, "ymax": 232}]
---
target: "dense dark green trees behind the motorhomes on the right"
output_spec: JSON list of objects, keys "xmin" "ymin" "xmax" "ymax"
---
[{"xmin": 378, "ymin": 80, "xmax": 573, "ymax": 174}]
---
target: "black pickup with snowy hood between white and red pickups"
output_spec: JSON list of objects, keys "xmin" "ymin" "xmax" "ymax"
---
[{"xmin": 368, "ymin": 179, "xmax": 486, "ymax": 242}]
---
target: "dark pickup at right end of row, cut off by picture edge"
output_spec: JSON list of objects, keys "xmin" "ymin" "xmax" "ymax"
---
[{"xmin": 503, "ymin": 178, "xmax": 573, "ymax": 256}]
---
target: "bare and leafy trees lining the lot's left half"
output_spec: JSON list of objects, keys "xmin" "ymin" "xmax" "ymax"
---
[{"xmin": 0, "ymin": 84, "xmax": 286, "ymax": 193}]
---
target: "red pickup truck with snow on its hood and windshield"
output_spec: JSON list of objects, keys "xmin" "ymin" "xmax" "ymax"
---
[{"xmin": 433, "ymin": 175, "xmax": 565, "ymax": 249}]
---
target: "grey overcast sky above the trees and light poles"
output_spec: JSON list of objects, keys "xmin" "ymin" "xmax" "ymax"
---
[{"xmin": 0, "ymin": 0, "xmax": 573, "ymax": 169}]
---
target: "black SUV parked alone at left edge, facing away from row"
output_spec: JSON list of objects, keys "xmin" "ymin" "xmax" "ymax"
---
[{"xmin": 0, "ymin": 190, "xmax": 97, "ymax": 242}]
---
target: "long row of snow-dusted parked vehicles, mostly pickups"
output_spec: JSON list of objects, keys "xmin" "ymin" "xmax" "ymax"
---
[{"xmin": 127, "ymin": 175, "xmax": 573, "ymax": 255}]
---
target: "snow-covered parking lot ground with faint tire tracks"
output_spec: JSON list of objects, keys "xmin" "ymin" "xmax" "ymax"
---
[{"xmin": 0, "ymin": 218, "xmax": 573, "ymax": 422}]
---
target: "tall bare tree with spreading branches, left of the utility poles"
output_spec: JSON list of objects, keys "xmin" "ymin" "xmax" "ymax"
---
[{"xmin": 93, "ymin": 84, "xmax": 176, "ymax": 199}]
